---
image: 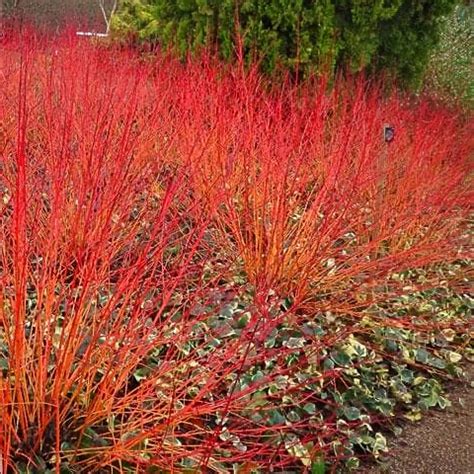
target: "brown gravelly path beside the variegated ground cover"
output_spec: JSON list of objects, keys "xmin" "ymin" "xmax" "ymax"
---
[{"xmin": 363, "ymin": 364, "xmax": 474, "ymax": 474}]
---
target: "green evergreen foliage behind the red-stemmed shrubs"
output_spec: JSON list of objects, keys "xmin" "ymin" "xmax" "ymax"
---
[{"xmin": 111, "ymin": 0, "xmax": 457, "ymax": 85}]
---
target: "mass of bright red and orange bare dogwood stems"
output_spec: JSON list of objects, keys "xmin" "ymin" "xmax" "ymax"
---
[{"xmin": 0, "ymin": 31, "xmax": 474, "ymax": 472}]
